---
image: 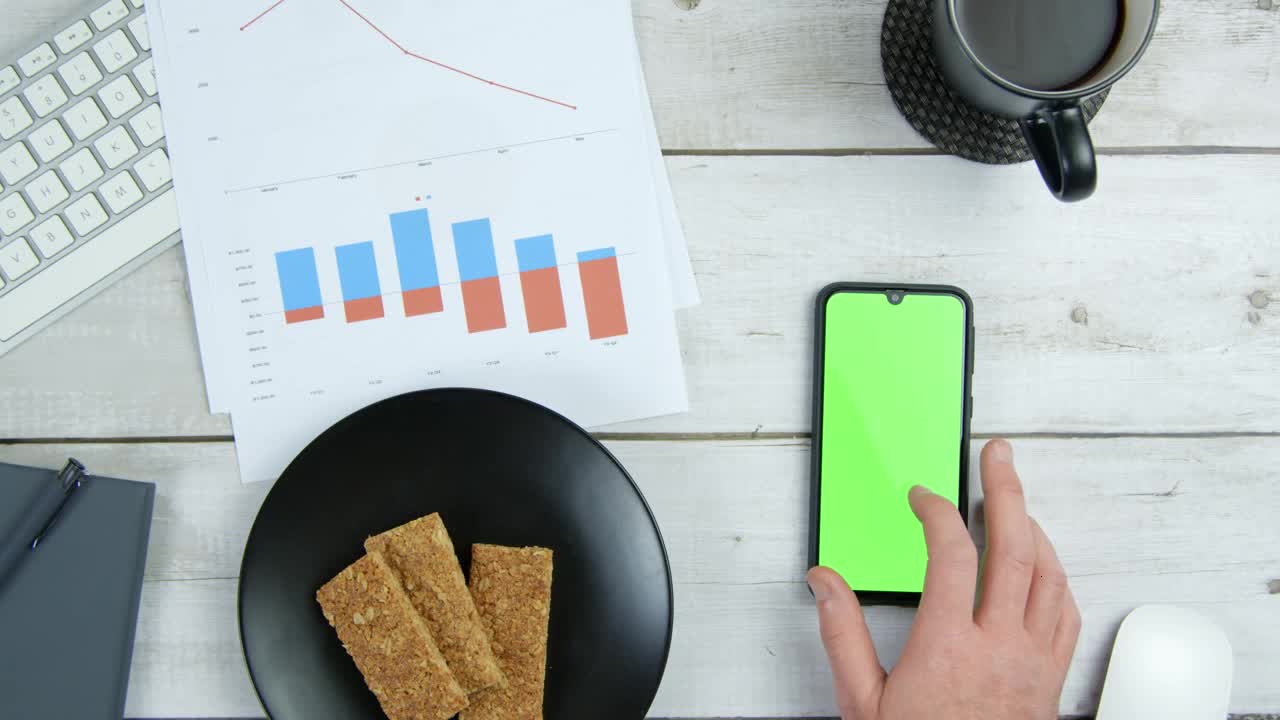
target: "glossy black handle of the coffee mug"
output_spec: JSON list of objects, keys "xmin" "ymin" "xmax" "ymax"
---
[{"xmin": 1018, "ymin": 105, "xmax": 1098, "ymax": 202}]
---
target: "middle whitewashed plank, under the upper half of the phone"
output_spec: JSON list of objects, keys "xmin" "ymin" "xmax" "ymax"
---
[{"xmin": 0, "ymin": 155, "xmax": 1280, "ymax": 438}]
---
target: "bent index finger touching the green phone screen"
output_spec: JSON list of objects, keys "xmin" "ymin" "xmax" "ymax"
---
[{"xmin": 909, "ymin": 486, "xmax": 978, "ymax": 623}]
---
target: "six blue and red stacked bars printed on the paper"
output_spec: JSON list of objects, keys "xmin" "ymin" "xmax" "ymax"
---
[{"xmin": 275, "ymin": 202, "xmax": 628, "ymax": 341}]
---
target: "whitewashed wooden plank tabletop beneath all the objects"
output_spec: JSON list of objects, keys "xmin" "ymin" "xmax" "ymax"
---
[{"xmin": 0, "ymin": 0, "xmax": 1280, "ymax": 717}]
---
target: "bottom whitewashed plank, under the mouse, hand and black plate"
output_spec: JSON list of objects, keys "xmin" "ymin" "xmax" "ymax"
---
[{"xmin": 0, "ymin": 438, "xmax": 1280, "ymax": 717}]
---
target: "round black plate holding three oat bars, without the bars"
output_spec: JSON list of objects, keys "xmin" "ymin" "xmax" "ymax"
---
[{"xmin": 239, "ymin": 389, "xmax": 672, "ymax": 720}]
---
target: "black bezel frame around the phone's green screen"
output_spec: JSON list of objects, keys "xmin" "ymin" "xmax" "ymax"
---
[{"xmin": 809, "ymin": 282, "xmax": 975, "ymax": 606}]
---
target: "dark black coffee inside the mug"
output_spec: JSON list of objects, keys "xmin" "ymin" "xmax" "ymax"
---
[{"xmin": 957, "ymin": 0, "xmax": 1124, "ymax": 90}]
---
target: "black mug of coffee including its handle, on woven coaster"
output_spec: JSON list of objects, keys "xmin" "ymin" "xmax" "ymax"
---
[{"xmin": 933, "ymin": 0, "xmax": 1160, "ymax": 202}]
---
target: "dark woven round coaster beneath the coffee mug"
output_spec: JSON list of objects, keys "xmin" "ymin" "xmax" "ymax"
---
[{"xmin": 881, "ymin": 0, "xmax": 1107, "ymax": 165}]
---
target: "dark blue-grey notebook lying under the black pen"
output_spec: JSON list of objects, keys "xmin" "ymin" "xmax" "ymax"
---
[{"xmin": 0, "ymin": 462, "xmax": 155, "ymax": 720}]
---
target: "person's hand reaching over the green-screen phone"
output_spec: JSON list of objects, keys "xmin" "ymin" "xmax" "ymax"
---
[{"xmin": 808, "ymin": 439, "xmax": 1080, "ymax": 720}]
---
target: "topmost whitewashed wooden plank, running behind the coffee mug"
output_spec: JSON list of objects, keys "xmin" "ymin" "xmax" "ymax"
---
[{"xmin": 0, "ymin": 0, "xmax": 1280, "ymax": 150}]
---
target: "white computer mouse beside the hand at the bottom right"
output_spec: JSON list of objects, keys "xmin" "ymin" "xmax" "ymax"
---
[{"xmin": 1097, "ymin": 605, "xmax": 1233, "ymax": 720}]
